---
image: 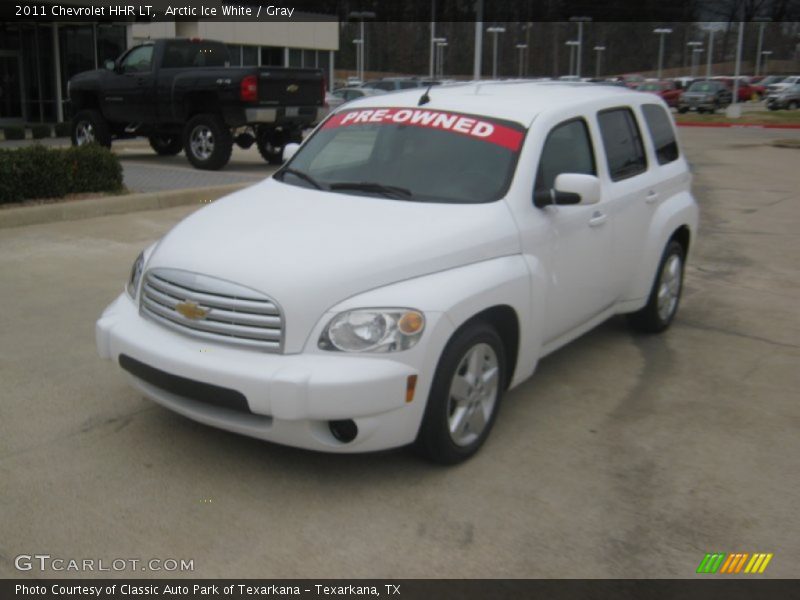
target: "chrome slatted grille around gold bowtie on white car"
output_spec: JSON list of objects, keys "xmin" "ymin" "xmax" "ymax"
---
[{"xmin": 140, "ymin": 269, "xmax": 283, "ymax": 352}]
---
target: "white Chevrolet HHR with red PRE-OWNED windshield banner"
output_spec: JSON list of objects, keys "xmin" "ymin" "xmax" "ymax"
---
[{"xmin": 97, "ymin": 82, "xmax": 698, "ymax": 463}]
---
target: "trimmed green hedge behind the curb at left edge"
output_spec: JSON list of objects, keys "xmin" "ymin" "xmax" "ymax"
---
[{"xmin": 0, "ymin": 144, "xmax": 122, "ymax": 204}]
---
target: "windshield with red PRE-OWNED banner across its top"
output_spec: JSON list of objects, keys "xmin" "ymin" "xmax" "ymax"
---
[{"xmin": 275, "ymin": 108, "xmax": 525, "ymax": 203}]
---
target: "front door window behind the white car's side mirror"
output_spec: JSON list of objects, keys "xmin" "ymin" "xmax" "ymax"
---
[{"xmin": 535, "ymin": 119, "xmax": 597, "ymax": 191}]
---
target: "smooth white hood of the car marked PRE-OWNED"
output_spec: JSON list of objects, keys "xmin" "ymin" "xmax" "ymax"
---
[{"xmin": 147, "ymin": 179, "xmax": 519, "ymax": 352}]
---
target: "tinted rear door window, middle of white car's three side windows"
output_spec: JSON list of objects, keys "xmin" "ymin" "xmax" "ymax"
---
[{"xmin": 597, "ymin": 108, "xmax": 647, "ymax": 181}]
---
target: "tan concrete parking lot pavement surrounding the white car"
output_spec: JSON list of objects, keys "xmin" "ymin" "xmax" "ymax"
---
[{"xmin": 0, "ymin": 129, "xmax": 800, "ymax": 578}]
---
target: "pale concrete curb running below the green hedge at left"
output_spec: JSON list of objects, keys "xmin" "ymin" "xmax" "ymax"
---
[{"xmin": 0, "ymin": 182, "xmax": 250, "ymax": 229}]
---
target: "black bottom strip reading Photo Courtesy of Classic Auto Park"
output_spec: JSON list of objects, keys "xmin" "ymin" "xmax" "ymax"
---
[{"xmin": 0, "ymin": 575, "xmax": 800, "ymax": 600}]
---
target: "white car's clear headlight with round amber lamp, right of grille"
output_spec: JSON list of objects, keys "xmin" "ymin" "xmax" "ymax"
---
[{"xmin": 319, "ymin": 308, "xmax": 425, "ymax": 352}]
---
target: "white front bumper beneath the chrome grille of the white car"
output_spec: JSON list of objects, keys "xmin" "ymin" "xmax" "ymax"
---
[{"xmin": 96, "ymin": 294, "xmax": 428, "ymax": 452}]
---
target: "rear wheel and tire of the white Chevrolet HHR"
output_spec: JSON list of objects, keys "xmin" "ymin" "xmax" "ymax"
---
[{"xmin": 628, "ymin": 240, "xmax": 686, "ymax": 333}]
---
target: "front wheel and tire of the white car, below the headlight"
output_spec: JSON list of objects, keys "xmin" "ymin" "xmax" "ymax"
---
[{"xmin": 415, "ymin": 321, "xmax": 506, "ymax": 465}]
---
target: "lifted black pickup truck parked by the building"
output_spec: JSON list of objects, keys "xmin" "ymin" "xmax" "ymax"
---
[{"xmin": 67, "ymin": 39, "xmax": 325, "ymax": 169}]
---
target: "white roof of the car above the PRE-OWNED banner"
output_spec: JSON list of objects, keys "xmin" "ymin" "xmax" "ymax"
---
[{"xmin": 337, "ymin": 81, "xmax": 641, "ymax": 126}]
